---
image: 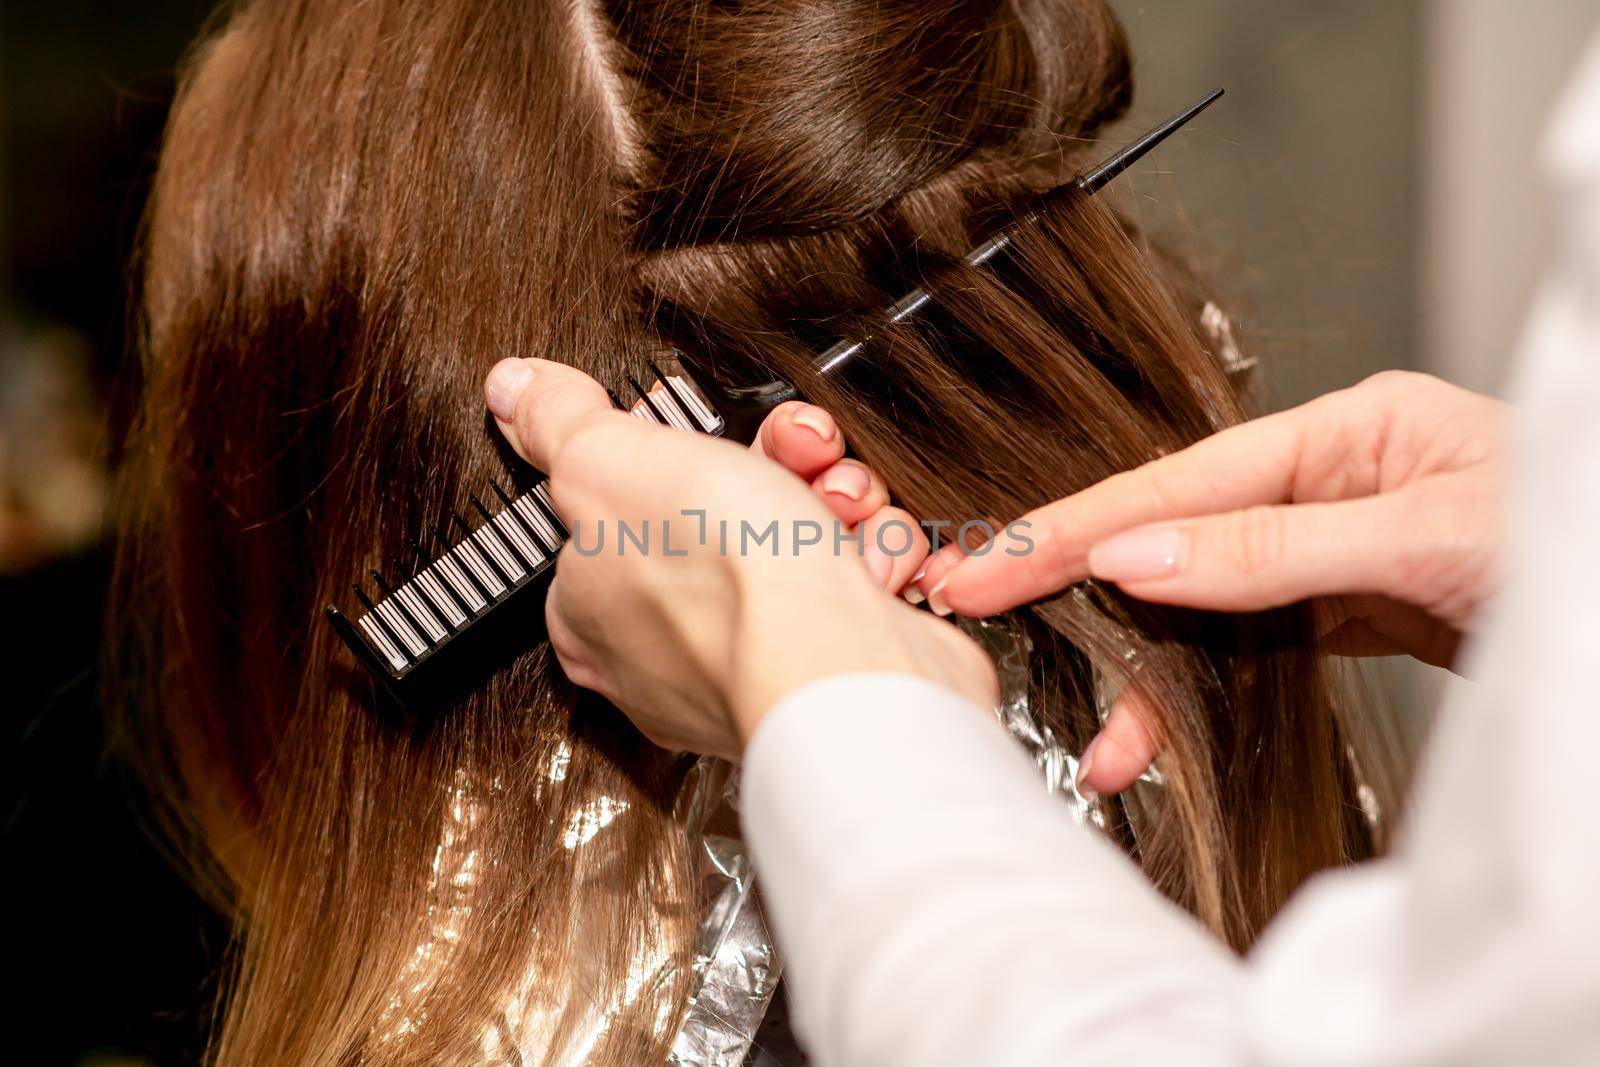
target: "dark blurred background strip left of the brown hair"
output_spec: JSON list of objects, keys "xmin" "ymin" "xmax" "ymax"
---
[{"xmin": 0, "ymin": 0, "xmax": 226, "ymax": 1065}]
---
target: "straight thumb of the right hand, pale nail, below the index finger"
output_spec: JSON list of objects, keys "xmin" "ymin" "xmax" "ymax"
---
[{"xmin": 1088, "ymin": 493, "xmax": 1437, "ymax": 611}]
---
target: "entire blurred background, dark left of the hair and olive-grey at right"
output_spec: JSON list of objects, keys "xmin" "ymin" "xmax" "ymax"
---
[{"xmin": 0, "ymin": 0, "xmax": 1600, "ymax": 1065}]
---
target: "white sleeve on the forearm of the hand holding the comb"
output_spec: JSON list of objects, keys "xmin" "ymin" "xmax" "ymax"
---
[{"xmin": 741, "ymin": 675, "xmax": 1240, "ymax": 1067}]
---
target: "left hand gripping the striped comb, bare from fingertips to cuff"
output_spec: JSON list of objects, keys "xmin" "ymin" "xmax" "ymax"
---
[{"xmin": 485, "ymin": 358, "xmax": 998, "ymax": 758}]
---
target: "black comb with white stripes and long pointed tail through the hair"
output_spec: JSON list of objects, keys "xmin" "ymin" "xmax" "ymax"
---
[{"xmin": 328, "ymin": 90, "xmax": 1222, "ymax": 712}]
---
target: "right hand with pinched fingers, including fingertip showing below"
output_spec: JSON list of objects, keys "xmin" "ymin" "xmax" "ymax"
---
[{"xmin": 918, "ymin": 371, "xmax": 1507, "ymax": 795}]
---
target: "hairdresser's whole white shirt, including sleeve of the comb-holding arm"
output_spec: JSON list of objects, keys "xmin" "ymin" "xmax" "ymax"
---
[{"xmin": 742, "ymin": 37, "xmax": 1600, "ymax": 1067}]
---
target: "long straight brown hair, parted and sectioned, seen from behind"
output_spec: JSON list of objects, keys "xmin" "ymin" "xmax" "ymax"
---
[{"xmin": 109, "ymin": 0, "xmax": 1401, "ymax": 1064}]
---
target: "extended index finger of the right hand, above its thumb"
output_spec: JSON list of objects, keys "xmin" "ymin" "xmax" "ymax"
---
[{"xmin": 936, "ymin": 410, "xmax": 1306, "ymax": 616}]
